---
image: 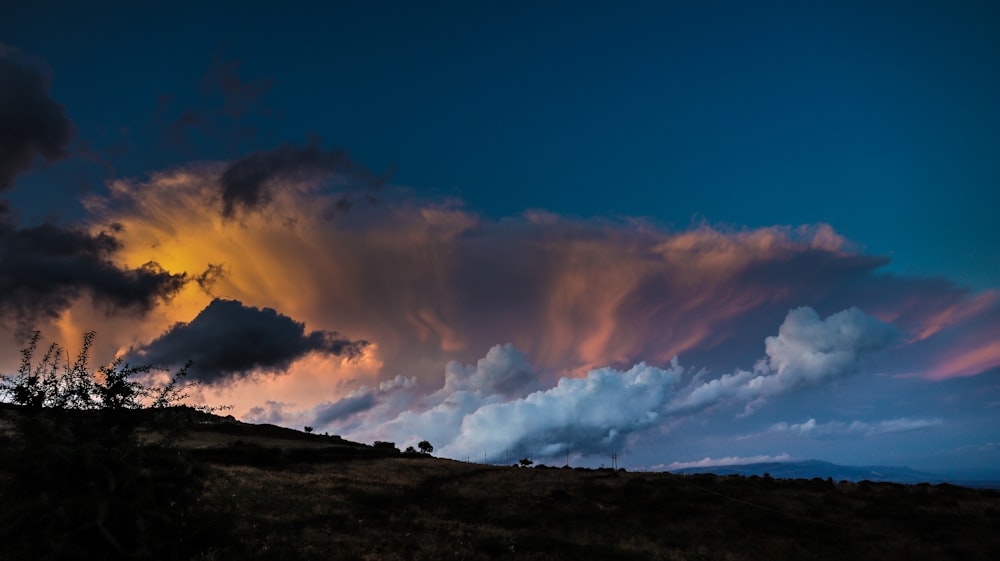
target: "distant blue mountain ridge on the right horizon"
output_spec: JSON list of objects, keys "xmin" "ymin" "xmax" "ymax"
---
[{"xmin": 670, "ymin": 460, "xmax": 956, "ymax": 484}]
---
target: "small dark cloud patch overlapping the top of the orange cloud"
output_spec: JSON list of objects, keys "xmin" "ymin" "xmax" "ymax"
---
[{"xmin": 219, "ymin": 142, "xmax": 354, "ymax": 217}]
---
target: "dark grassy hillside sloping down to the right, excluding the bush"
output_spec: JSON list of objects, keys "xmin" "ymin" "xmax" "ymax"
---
[{"xmin": 0, "ymin": 406, "xmax": 1000, "ymax": 561}]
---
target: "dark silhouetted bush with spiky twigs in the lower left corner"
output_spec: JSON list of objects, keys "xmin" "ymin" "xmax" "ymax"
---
[{"xmin": 0, "ymin": 333, "xmax": 225, "ymax": 560}]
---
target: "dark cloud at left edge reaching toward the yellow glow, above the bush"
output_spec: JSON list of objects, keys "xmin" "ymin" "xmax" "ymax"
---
[{"xmin": 0, "ymin": 224, "xmax": 187, "ymax": 323}]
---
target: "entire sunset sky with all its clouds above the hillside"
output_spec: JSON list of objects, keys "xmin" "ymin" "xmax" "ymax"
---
[{"xmin": 0, "ymin": 0, "xmax": 1000, "ymax": 477}]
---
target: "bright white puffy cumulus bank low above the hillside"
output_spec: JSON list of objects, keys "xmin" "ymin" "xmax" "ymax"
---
[{"xmin": 319, "ymin": 308, "xmax": 902, "ymax": 460}]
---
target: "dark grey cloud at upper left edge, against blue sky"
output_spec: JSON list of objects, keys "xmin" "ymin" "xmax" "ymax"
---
[{"xmin": 0, "ymin": 44, "xmax": 74, "ymax": 190}]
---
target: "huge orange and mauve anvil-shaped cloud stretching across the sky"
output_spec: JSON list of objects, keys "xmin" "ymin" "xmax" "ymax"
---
[{"xmin": 0, "ymin": 156, "xmax": 997, "ymax": 416}]
